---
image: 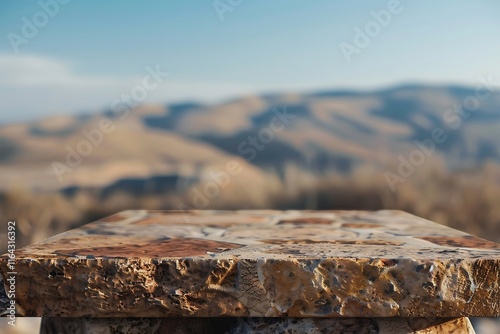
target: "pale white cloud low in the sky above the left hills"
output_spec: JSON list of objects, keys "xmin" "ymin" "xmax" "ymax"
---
[{"xmin": 0, "ymin": 53, "xmax": 258, "ymax": 123}]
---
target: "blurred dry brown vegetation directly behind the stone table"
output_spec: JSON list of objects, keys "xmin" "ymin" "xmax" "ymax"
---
[{"xmin": 0, "ymin": 163, "xmax": 500, "ymax": 253}]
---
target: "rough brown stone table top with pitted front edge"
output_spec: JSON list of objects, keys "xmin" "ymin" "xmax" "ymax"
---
[{"xmin": 0, "ymin": 211, "xmax": 500, "ymax": 317}]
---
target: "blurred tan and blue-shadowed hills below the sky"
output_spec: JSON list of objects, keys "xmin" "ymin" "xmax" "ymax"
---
[{"xmin": 0, "ymin": 85, "xmax": 500, "ymax": 193}]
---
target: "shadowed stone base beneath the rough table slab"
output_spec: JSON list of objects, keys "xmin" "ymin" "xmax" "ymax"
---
[{"xmin": 40, "ymin": 318, "xmax": 474, "ymax": 334}]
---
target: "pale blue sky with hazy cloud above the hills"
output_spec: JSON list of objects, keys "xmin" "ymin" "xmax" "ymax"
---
[{"xmin": 0, "ymin": 0, "xmax": 500, "ymax": 123}]
